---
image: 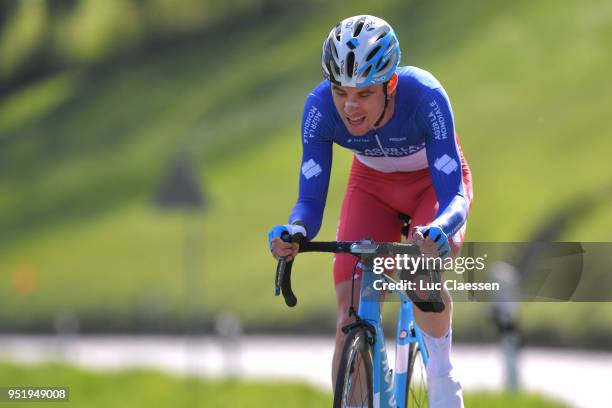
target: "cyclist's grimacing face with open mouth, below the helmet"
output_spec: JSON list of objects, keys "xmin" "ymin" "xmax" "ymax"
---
[{"xmin": 332, "ymin": 84, "xmax": 385, "ymax": 136}]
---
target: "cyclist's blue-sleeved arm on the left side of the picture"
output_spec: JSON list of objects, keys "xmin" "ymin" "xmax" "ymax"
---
[{"xmin": 289, "ymin": 94, "xmax": 333, "ymax": 240}]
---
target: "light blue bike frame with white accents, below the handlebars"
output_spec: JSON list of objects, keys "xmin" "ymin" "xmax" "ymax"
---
[{"xmin": 359, "ymin": 262, "xmax": 428, "ymax": 408}]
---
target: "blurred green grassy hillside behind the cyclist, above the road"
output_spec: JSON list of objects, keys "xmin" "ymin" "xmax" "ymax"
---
[{"xmin": 0, "ymin": 0, "xmax": 612, "ymax": 392}]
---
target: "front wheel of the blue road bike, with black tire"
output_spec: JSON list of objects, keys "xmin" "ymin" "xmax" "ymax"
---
[{"xmin": 334, "ymin": 327, "xmax": 374, "ymax": 408}]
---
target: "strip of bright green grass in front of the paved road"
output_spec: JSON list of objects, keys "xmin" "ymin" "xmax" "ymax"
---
[{"xmin": 0, "ymin": 363, "xmax": 565, "ymax": 408}]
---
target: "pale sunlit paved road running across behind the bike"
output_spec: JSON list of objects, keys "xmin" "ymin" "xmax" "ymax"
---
[{"xmin": 0, "ymin": 335, "xmax": 612, "ymax": 408}]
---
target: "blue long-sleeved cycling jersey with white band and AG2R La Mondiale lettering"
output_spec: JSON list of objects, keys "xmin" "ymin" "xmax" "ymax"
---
[{"xmin": 289, "ymin": 67, "xmax": 468, "ymax": 239}]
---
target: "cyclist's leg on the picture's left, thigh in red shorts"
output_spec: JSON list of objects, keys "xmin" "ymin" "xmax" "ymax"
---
[{"xmin": 332, "ymin": 159, "xmax": 401, "ymax": 387}]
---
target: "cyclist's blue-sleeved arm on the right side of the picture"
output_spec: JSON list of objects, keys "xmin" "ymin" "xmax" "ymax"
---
[{"xmin": 417, "ymin": 88, "xmax": 469, "ymax": 237}]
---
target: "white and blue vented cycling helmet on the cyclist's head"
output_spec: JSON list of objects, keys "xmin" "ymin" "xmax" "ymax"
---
[{"xmin": 321, "ymin": 15, "xmax": 401, "ymax": 88}]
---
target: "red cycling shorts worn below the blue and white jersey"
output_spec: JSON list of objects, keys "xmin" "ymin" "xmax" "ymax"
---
[{"xmin": 334, "ymin": 150, "xmax": 473, "ymax": 285}]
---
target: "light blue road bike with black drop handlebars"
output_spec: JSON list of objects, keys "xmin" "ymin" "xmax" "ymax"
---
[{"xmin": 275, "ymin": 234, "xmax": 444, "ymax": 408}]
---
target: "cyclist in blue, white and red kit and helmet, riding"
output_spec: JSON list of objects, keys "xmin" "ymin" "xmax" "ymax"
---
[{"xmin": 268, "ymin": 15, "xmax": 472, "ymax": 408}]
